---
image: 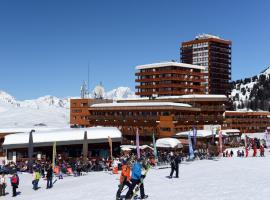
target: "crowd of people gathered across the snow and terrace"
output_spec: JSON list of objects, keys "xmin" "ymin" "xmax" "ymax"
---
[{"xmin": 0, "ymin": 137, "xmax": 265, "ymax": 200}]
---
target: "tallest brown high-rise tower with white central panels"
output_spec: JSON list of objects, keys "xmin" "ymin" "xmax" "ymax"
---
[{"xmin": 181, "ymin": 34, "xmax": 232, "ymax": 95}]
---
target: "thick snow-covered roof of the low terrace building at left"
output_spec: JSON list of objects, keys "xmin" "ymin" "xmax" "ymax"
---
[{"xmin": 3, "ymin": 127, "xmax": 122, "ymax": 148}]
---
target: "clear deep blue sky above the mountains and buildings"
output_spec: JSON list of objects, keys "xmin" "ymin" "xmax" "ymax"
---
[{"xmin": 0, "ymin": 0, "xmax": 270, "ymax": 99}]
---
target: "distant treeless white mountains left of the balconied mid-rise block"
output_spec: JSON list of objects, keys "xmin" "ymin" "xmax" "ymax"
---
[{"xmin": 0, "ymin": 87, "xmax": 135, "ymax": 128}]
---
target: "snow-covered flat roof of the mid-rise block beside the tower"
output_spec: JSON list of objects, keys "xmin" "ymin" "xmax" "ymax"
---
[{"xmin": 136, "ymin": 62, "xmax": 205, "ymax": 70}]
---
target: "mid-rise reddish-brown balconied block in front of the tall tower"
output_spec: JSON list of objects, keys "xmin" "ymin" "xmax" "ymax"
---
[{"xmin": 136, "ymin": 62, "xmax": 207, "ymax": 97}]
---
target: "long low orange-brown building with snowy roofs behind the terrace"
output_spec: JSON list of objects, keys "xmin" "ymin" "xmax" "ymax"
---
[{"xmin": 70, "ymin": 95, "xmax": 227, "ymax": 144}]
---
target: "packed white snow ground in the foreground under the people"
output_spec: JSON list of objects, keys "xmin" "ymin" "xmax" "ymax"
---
[{"xmin": 3, "ymin": 154, "xmax": 270, "ymax": 200}]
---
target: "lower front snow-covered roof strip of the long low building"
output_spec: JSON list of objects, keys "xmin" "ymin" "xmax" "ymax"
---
[{"xmin": 91, "ymin": 102, "xmax": 192, "ymax": 108}]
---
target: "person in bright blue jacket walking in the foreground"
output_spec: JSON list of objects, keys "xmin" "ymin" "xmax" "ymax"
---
[{"xmin": 126, "ymin": 158, "xmax": 148, "ymax": 200}]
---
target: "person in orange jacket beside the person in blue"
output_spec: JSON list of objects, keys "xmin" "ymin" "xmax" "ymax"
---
[{"xmin": 116, "ymin": 160, "xmax": 131, "ymax": 199}]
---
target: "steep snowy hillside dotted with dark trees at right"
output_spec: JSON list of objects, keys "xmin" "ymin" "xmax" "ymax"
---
[{"xmin": 231, "ymin": 67, "xmax": 270, "ymax": 111}]
